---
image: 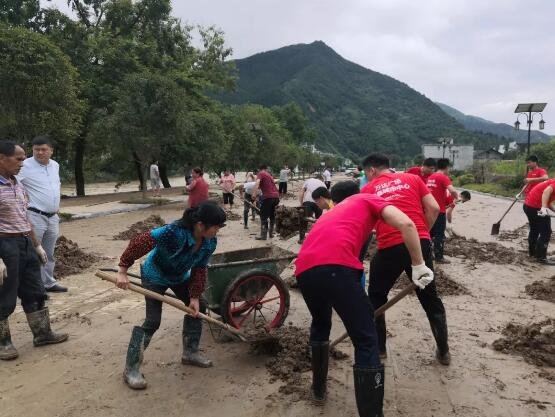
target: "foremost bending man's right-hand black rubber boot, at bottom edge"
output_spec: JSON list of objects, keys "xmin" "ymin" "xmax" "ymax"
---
[{"xmin": 353, "ymin": 366, "xmax": 384, "ymax": 417}]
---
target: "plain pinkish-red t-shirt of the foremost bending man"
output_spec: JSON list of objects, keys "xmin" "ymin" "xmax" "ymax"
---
[{"xmin": 295, "ymin": 193, "xmax": 389, "ymax": 277}]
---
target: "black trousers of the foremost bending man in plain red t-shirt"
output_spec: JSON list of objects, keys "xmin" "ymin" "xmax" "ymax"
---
[{"xmin": 298, "ymin": 265, "xmax": 381, "ymax": 368}]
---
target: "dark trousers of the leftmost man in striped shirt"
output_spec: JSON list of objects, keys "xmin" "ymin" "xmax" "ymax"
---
[{"xmin": 0, "ymin": 236, "xmax": 46, "ymax": 320}]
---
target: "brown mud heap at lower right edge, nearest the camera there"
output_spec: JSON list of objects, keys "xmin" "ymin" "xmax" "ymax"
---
[{"xmin": 493, "ymin": 319, "xmax": 555, "ymax": 367}]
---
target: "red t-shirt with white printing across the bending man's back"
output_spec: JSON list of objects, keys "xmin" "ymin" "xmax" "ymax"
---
[{"xmin": 361, "ymin": 172, "xmax": 430, "ymax": 249}]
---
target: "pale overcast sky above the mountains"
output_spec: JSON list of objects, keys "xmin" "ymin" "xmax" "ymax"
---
[{"xmin": 47, "ymin": 0, "xmax": 555, "ymax": 135}]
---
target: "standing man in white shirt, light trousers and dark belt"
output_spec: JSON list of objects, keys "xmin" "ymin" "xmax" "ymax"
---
[{"xmin": 17, "ymin": 136, "xmax": 67, "ymax": 292}]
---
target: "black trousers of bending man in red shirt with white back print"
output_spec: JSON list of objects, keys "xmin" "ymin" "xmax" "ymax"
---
[{"xmin": 368, "ymin": 239, "xmax": 448, "ymax": 352}]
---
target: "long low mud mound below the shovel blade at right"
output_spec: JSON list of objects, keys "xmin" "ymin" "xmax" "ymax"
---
[{"xmin": 445, "ymin": 235, "xmax": 527, "ymax": 265}]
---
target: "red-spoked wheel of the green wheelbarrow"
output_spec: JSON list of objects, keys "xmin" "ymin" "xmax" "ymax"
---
[{"xmin": 221, "ymin": 270, "xmax": 289, "ymax": 329}]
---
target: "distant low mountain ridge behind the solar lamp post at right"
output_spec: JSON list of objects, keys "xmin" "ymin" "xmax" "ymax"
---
[{"xmin": 436, "ymin": 102, "xmax": 551, "ymax": 143}]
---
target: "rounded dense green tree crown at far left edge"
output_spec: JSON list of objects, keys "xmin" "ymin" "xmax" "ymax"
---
[{"xmin": 0, "ymin": 25, "xmax": 82, "ymax": 144}]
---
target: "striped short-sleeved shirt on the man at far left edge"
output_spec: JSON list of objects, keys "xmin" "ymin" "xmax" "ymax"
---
[{"xmin": 0, "ymin": 175, "xmax": 31, "ymax": 233}]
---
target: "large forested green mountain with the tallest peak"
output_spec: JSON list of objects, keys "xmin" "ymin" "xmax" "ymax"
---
[{"xmin": 217, "ymin": 41, "xmax": 503, "ymax": 160}]
